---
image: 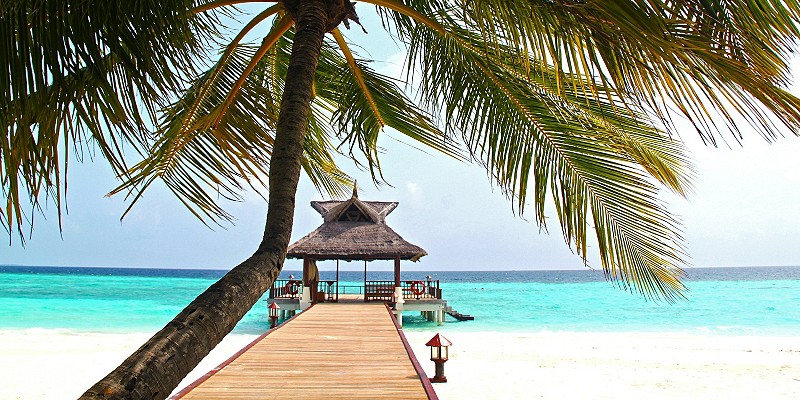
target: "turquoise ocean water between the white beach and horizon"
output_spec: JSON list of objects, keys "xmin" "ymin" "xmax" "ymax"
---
[{"xmin": 0, "ymin": 266, "xmax": 800, "ymax": 336}]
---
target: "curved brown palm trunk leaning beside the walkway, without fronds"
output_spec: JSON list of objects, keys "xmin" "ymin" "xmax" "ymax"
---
[{"xmin": 81, "ymin": 0, "xmax": 328, "ymax": 400}]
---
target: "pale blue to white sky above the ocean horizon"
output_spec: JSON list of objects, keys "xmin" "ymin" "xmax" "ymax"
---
[{"xmin": 0, "ymin": 10, "xmax": 800, "ymax": 270}]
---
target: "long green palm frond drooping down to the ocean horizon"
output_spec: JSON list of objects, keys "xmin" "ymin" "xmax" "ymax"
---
[{"xmin": 378, "ymin": 1, "xmax": 690, "ymax": 299}]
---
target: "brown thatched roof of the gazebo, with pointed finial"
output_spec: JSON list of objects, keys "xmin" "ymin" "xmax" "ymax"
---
[{"xmin": 287, "ymin": 189, "xmax": 428, "ymax": 261}]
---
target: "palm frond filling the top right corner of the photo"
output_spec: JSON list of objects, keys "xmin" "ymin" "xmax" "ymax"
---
[{"xmin": 454, "ymin": 0, "xmax": 800, "ymax": 143}]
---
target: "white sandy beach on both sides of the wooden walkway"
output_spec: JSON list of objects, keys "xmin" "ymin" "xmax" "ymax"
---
[{"xmin": 0, "ymin": 330, "xmax": 800, "ymax": 400}]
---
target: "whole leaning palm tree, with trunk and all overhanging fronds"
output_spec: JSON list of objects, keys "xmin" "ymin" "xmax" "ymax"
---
[{"xmin": 0, "ymin": 0, "xmax": 800, "ymax": 398}]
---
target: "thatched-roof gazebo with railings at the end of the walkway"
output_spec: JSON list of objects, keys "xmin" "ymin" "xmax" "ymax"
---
[{"xmin": 267, "ymin": 188, "xmax": 460, "ymax": 325}]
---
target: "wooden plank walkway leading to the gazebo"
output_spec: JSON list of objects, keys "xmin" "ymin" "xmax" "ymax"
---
[{"xmin": 172, "ymin": 303, "xmax": 438, "ymax": 400}]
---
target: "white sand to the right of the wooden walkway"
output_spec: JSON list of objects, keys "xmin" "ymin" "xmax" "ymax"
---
[{"xmin": 407, "ymin": 332, "xmax": 800, "ymax": 400}]
